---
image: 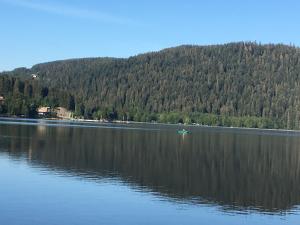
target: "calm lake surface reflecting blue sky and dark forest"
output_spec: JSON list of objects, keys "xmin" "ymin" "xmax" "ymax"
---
[{"xmin": 0, "ymin": 120, "xmax": 300, "ymax": 225}]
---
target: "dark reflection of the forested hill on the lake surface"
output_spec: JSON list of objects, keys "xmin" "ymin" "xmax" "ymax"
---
[{"xmin": 0, "ymin": 125, "xmax": 300, "ymax": 212}]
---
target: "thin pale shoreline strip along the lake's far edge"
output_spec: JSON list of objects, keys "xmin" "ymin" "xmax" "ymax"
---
[{"xmin": 0, "ymin": 115, "xmax": 300, "ymax": 134}]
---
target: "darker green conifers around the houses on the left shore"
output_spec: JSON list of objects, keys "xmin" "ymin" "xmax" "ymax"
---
[{"xmin": 0, "ymin": 75, "xmax": 75, "ymax": 118}]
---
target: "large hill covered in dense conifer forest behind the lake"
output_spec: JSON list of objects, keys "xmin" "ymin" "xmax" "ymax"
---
[{"xmin": 0, "ymin": 43, "xmax": 300, "ymax": 129}]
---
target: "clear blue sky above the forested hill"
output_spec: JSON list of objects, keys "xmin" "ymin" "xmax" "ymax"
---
[{"xmin": 0, "ymin": 0, "xmax": 300, "ymax": 71}]
